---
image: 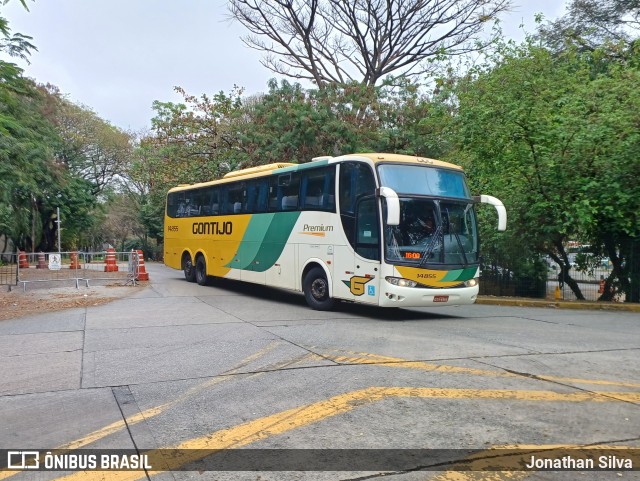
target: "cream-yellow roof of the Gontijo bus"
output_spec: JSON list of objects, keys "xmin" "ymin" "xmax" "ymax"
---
[{"xmin": 169, "ymin": 153, "xmax": 462, "ymax": 192}]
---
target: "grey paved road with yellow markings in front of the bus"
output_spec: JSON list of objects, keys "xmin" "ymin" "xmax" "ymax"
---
[{"xmin": 0, "ymin": 264, "xmax": 640, "ymax": 481}]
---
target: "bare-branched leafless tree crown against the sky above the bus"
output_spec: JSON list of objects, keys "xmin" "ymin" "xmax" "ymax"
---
[{"xmin": 229, "ymin": 0, "xmax": 510, "ymax": 88}]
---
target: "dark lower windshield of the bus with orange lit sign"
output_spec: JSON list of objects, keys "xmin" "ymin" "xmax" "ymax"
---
[{"xmin": 385, "ymin": 197, "xmax": 478, "ymax": 267}]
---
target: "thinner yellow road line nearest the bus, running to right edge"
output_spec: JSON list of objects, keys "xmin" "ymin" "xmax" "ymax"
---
[{"xmin": 326, "ymin": 353, "xmax": 640, "ymax": 388}]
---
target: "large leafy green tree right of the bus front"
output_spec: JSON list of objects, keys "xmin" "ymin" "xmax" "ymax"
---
[{"xmin": 455, "ymin": 43, "xmax": 640, "ymax": 300}]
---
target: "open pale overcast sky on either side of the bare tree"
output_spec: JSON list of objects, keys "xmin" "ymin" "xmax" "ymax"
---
[{"xmin": 0, "ymin": 0, "xmax": 564, "ymax": 130}]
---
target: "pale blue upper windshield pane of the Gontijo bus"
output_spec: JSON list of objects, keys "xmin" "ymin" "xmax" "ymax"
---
[{"xmin": 378, "ymin": 164, "xmax": 471, "ymax": 199}]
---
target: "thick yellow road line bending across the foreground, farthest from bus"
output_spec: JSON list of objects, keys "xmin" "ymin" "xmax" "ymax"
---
[{"xmin": 51, "ymin": 387, "xmax": 640, "ymax": 481}]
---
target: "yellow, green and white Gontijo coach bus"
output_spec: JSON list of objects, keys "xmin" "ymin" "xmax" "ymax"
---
[{"xmin": 164, "ymin": 153, "xmax": 506, "ymax": 310}]
